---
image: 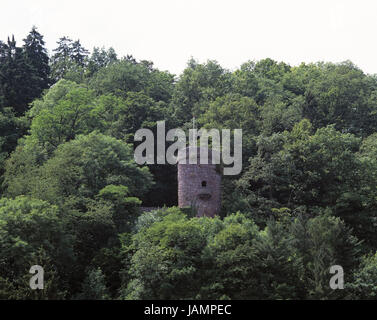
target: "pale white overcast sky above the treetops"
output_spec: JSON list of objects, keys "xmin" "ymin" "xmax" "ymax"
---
[{"xmin": 0, "ymin": 0, "xmax": 377, "ymax": 74}]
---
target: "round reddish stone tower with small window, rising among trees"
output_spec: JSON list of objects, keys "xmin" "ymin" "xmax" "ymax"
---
[{"xmin": 178, "ymin": 147, "xmax": 221, "ymax": 217}]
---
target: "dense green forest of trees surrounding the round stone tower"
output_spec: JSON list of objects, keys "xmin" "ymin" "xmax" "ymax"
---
[{"xmin": 0, "ymin": 27, "xmax": 377, "ymax": 300}]
